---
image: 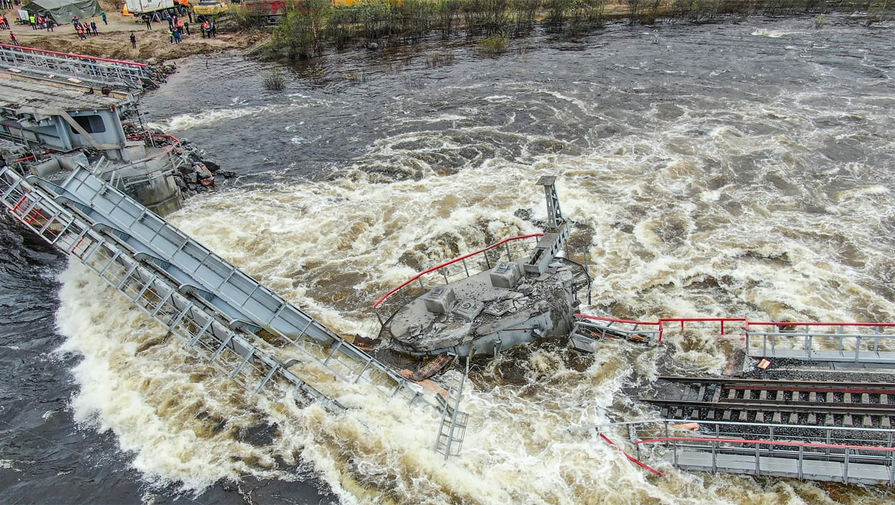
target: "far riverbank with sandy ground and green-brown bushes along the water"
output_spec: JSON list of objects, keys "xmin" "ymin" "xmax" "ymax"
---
[{"xmin": 2, "ymin": 0, "xmax": 891, "ymax": 63}]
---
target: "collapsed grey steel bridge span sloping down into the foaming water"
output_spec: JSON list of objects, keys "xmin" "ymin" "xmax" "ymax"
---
[{"xmin": 0, "ymin": 166, "xmax": 472, "ymax": 452}]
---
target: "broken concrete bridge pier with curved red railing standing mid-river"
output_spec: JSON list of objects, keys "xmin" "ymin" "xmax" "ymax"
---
[{"xmin": 375, "ymin": 176, "xmax": 590, "ymax": 357}]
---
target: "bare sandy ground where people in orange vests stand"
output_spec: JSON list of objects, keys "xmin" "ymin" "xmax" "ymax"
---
[{"xmin": 0, "ymin": 6, "xmax": 269, "ymax": 61}]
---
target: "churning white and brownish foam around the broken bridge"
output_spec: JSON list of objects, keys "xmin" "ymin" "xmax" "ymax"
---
[{"xmin": 59, "ymin": 18, "xmax": 895, "ymax": 505}]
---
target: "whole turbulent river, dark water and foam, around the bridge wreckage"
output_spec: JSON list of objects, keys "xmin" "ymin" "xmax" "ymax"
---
[{"xmin": 0, "ymin": 13, "xmax": 895, "ymax": 505}]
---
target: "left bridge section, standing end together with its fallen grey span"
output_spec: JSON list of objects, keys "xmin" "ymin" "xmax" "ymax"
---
[{"xmin": 0, "ymin": 44, "xmax": 476, "ymax": 457}]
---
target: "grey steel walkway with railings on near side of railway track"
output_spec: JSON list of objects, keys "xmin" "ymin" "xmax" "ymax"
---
[{"xmin": 570, "ymin": 419, "xmax": 895, "ymax": 486}]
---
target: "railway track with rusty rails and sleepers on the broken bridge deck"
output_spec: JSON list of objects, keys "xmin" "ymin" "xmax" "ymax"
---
[{"xmin": 641, "ymin": 376, "xmax": 895, "ymax": 428}]
